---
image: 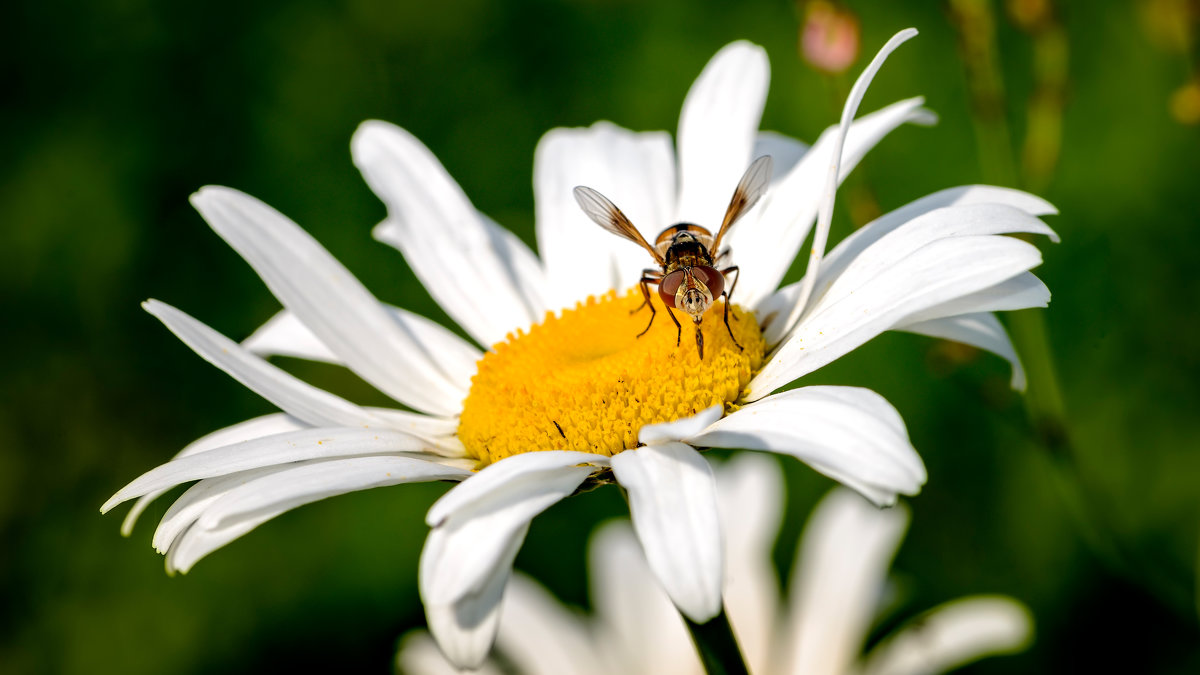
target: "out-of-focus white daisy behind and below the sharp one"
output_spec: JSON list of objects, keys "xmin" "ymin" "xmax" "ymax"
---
[{"xmin": 397, "ymin": 454, "xmax": 1033, "ymax": 675}]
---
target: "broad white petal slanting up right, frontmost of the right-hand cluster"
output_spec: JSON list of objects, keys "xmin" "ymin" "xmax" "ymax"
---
[{"xmin": 744, "ymin": 235, "xmax": 1042, "ymax": 401}]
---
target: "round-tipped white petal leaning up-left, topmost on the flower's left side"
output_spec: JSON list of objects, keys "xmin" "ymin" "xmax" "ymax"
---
[{"xmin": 350, "ymin": 120, "xmax": 546, "ymax": 345}]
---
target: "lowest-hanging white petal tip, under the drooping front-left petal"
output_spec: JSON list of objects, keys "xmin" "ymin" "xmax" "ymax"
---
[{"xmin": 420, "ymin": 522, "xmax": 520, "ymax": 669}]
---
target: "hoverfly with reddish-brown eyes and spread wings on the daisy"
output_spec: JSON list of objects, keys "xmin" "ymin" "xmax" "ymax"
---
[{"xmin": 575, "ymin": 155, "xmax": 772, "ymax": 359}]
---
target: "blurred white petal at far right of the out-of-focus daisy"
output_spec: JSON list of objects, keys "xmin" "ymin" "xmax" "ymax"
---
[{"xmin": 863, "ymin": 596, "xmax": 1033, "ymax": 675}]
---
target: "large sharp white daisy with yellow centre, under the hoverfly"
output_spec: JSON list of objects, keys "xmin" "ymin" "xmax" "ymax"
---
[{"xmin": 102, "ymin": 29, "xmax": 1052, "ymax": 665}]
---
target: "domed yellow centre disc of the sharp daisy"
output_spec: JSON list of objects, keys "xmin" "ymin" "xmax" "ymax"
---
[{"xmin": 458, "ymin": 289, "xmax": 763, "ymax": 465}]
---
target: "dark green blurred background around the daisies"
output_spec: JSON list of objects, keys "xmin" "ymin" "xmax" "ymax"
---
[{"xmin": 0, "ymin": 0, "xmax": 1200, "ymax": 675}]
